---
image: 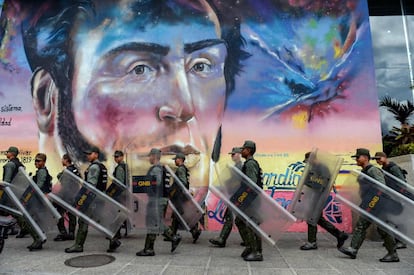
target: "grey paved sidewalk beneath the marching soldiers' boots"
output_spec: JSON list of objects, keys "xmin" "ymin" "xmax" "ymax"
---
[{"xmin": 0, "ymin": 228, "xmax": 414, "ymax": 275}]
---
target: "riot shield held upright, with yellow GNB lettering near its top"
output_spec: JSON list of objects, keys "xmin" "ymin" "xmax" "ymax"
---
[{"xmin": 130, "ymin": 176, "xmax": 167, "ymax": 234}]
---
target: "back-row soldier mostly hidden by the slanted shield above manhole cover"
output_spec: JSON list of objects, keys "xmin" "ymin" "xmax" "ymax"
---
[{"xmin": 53, "ymin": 154, "xmax": 81, "ymax": 242}]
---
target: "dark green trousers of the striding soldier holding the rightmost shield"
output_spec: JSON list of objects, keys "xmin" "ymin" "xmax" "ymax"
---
[{"xmin": 351, "ymin": 218, "xmax": 395, "ymax": 253}]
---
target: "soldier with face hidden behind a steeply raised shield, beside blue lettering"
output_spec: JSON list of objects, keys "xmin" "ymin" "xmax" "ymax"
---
[{"xmin": 300, "ymin": 152, "xmax": 348, "ymax": 250}]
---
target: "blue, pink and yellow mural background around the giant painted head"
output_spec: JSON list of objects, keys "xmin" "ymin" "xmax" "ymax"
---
[{"xmin": 0, "ymin": 0, "xmax": 381, "ymax": 231}]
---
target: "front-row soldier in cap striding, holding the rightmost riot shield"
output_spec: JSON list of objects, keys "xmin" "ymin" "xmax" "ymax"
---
[{"xmin": 339, "ymin": 148, "xmax": 400, "ymax": 262}]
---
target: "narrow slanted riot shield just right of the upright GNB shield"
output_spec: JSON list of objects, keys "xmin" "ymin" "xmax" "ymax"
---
[{"xmin": 165, "ymin": 165, "xmax": 204, "ymax": 231}]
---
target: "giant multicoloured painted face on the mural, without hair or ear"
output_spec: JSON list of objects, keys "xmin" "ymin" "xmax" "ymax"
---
[{"xmin": 72, "ymin": 0, "xmax": 227, "ymax": 186}]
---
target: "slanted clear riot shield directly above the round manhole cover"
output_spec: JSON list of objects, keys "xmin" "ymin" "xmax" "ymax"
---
[{"xmin": 49, "ymin": 169, "xmax": 129, "ymax": 238}]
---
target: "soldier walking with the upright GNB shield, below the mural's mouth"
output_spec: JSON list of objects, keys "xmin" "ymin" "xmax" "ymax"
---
[{"xmin": 136, "ymin": 148, "xmax": 181, "ymax": 256}]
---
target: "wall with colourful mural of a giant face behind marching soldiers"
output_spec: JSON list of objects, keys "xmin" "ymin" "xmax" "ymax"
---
[{"xmin": 0, "ymin": 0, "xmax": 381, "ymax": 233}]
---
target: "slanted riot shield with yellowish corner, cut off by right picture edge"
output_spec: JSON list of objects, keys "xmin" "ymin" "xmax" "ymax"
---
[{"xmin": 336, "ymin": 170, "xmax": 414, "ymax": 245}]
